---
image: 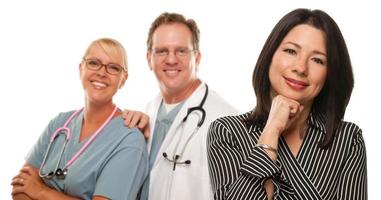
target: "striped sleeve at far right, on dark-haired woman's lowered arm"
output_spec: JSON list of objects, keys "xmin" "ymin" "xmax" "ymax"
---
[{"xmin": 336, "ymin": 126, "xmax": 368, "ymax": 200}]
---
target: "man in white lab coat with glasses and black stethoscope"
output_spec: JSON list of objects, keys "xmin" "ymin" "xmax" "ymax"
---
[{"xmin": 125, "ymin": 13, "xmax": 238, "ymax": 200}]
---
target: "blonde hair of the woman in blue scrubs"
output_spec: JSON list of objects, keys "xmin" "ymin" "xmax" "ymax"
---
[{"xmin": 83, "ymin": 38, "xmax": 128, "ymax": 73}]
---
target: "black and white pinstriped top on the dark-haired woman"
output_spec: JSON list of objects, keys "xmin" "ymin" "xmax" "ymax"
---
[{"xmin": 208, "ymin": 113, "xmax": 367, "ymax": 200}]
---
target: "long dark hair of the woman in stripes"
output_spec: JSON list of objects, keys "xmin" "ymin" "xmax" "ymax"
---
[{"xmin": 246, "ymin": 9, "xmax": 354, "ymax": 148}]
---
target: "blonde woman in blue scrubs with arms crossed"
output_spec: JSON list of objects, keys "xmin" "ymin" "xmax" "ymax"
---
[{"xmin": 12, "ymin": 38, "xmax": 148, "ymax": 200}]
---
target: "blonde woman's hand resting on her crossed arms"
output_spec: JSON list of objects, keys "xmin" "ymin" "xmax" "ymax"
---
[{"xmin": 11, "ymin": 166, "xmax": 47, "ymax": 199}]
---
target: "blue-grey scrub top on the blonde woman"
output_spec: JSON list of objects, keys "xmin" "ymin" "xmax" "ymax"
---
[{"xmin": 26, "ymin": 111, "xmax": 149, "ymax": 199}]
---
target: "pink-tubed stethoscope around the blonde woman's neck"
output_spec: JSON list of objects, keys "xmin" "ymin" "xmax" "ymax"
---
[{"xmin": 38, "ymin": 106, "xmax": 118, "ymax": 179}]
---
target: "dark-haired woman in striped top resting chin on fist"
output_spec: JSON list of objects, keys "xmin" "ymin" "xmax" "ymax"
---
[{"xmin": 208, "ymin": 9, "xmax": 367, "ymax": 200}]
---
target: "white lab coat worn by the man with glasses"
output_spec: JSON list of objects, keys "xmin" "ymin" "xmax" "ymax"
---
[{"xmin": 147, "ymin": 83, "xmax": 239, "ymax": 200}]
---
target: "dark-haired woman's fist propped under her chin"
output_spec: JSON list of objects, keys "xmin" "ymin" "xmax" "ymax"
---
[{"xmin": 265, "ymin": 95, "xmax": 304, "ymax": 137}]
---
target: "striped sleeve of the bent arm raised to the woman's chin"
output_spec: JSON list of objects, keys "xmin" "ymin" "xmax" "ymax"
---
[{"xmin": 208, "ymin": 120, "xmax": 276, "ymax": 200}]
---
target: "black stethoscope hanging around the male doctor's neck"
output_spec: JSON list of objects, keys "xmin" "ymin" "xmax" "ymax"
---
[{"xmin": 163, "ymin": 84, "xmax": 208, "ymax": 171}]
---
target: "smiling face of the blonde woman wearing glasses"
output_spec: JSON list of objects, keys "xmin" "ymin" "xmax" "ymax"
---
[{"xmin": 80, "ymin": 44, "xmax": 127, "ymax": 104}]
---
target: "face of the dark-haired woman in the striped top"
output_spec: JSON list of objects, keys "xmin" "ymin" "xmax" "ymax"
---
[{"xmin": 269, "ymin": 24, "xmax": 327, "ymax": 105}]
